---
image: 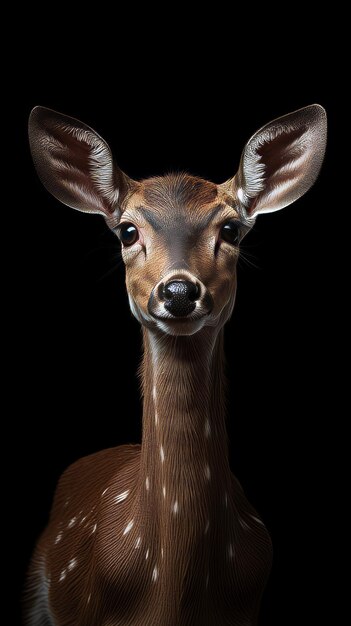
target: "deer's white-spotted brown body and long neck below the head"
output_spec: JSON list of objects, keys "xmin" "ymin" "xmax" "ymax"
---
[{"xmin": 31, "ymin": 326, "xmax": 271, "ymax": 625}]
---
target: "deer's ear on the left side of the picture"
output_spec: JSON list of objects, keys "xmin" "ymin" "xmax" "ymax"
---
[{"xmin": 29, "ymin": 107, "xmax": 133, "ymax": 218}]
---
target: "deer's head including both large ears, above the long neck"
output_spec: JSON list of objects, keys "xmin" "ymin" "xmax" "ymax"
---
[{"xmin": 29, "ymin": 105, "xmax": 326, "ymax": 335}]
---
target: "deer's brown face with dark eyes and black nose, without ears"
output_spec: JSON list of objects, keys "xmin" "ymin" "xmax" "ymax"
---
[{"xmin": 115, "ymin": 174, "xmax": 248, "ymax": 335}]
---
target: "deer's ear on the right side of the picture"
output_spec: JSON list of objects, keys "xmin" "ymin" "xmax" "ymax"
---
[{"xmin": 223, "ymin": 104, "xmax": 327, "ymax": 217}]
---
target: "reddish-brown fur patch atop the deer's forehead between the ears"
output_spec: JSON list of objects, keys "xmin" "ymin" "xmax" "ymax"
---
[{"xmin": 140, "ymin": 173, "xmax": 218, "ymax": 210}]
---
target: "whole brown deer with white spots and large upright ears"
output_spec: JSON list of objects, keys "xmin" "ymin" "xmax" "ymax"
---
[{"xmin": 25, "ymin": 104, "xmax": 326, "ymax": 626}]
